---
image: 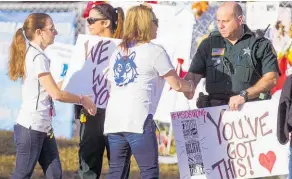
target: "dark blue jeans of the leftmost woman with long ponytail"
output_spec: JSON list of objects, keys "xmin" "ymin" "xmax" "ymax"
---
[{"xmin": 12, "ymin": 124, "xmax": 62, "ymax": 179}]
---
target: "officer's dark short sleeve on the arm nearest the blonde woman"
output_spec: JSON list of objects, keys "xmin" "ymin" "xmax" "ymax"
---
[{"xmin": 189, "ymin": 38, "xmax": 209, "ymax": 76}]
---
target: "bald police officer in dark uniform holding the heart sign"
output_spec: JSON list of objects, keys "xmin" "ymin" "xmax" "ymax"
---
[{"xmin": 184, "ymin": 2, "xmax": 279, "ymax": 110}]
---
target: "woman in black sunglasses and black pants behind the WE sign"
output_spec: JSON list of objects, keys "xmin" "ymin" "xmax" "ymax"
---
[{"xmin": 78, "ymin": 2, "xmax": 124, "ymax": 179}]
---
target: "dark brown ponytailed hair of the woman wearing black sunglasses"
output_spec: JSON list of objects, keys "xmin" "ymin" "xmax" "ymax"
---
[{"xmin": 92, "ymin": 3, "xmax": 124, "ymax": 39}]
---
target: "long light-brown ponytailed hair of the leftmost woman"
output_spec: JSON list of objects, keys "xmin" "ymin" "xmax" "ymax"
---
[{"xmin": 8, "ymin": 13, "xmax": 50, "ymax": 81}]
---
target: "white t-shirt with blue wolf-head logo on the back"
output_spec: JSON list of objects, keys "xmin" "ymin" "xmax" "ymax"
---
[{"xmin": 104, "ymin": 43, "xmax": 174, "ymax": 134}]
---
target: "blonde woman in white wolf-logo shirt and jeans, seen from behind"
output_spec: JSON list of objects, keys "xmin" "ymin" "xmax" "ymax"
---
[{"xmin": 104, "ymin": 4, "xmax": 194, "ymax": 179}]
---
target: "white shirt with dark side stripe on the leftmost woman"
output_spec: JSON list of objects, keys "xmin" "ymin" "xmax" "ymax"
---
[{"xmin": 17, "ymin": 42, "xmax": 52, "ymax": 132}]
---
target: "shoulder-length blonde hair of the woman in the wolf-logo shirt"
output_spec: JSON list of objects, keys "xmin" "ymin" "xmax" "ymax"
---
[{"xmin": 120, "ymin": 5, "xmax": 155, "ymax": 51}]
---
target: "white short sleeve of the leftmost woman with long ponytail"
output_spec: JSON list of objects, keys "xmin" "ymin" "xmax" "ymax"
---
[{"xmin": 33, "ymin": 54, "xmax": 50, "ymax": 77}]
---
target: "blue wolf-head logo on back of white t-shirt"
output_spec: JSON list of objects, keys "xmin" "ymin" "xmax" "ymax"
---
[{"xmin": 113, "ymin": 52, "xmax": 139, "ymax": 86}]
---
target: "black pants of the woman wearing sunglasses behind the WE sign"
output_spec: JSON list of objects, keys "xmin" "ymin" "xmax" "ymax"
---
[{"xmin": 78, "ymin": 109, "xmax": 110, "ymax": 179}]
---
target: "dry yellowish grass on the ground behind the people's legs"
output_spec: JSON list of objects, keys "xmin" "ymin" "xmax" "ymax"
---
[{"xmin": 0, "ymin": 131, "xmax": 286, "ymax": 179}]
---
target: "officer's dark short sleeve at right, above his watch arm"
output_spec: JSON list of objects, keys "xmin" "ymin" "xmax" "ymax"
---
[{"xmin": 256, "ymin": 39, "xmax": 280, "ymax": 75}]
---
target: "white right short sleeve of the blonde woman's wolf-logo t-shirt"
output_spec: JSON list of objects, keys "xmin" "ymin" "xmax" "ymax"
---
[{"xmin": 154, "ymin": 50, "xmax": 174, "ymax": 76}]
